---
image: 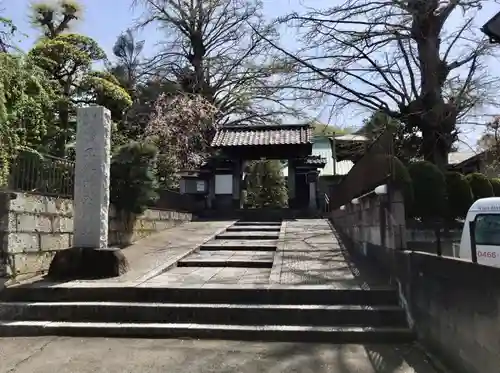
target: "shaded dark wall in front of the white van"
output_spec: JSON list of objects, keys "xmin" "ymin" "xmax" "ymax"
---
[{"xmin": 395, "ymin": 251, "xmax": 500, "ymax": 373}]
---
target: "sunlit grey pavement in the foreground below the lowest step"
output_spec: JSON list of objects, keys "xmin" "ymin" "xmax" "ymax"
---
[{"xmin": 0, "ymin": 337, "xmax": 444, "ymax": 373}]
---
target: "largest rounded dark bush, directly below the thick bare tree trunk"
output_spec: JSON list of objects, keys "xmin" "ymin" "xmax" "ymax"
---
[{"xmin": 408, "ymin": 161, "xmax": 446, "ymax": 220}]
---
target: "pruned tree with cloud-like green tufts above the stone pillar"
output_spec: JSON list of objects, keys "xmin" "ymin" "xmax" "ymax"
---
[{"xmin": 29, "ymin": 0, "xmax": 132, "ymax": 155}]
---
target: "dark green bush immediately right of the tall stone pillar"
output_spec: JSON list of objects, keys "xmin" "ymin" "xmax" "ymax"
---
[{"xmin": 110, "ymin": 141, "xmax": 158, "ymax": 214}]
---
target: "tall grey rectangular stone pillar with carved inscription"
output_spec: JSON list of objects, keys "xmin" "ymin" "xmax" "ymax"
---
[{"xmin": 73, "ymin": 106, "xmax": 111, "ymax": 249}]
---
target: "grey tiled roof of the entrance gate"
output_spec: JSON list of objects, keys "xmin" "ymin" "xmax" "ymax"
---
[{"xmin": 211, "ymin": 125, "xmax": 313, "ymax": 148}]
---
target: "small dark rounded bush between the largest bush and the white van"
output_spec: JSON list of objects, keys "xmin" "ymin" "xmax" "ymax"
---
[{"xmin": 445, "ymin": 172, "xmax": 474, "ymax": 220}]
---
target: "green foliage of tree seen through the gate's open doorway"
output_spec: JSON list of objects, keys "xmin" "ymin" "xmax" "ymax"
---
[{"xmin": 246, "ymin": 160, "xmax": 288, "ymax": 208}]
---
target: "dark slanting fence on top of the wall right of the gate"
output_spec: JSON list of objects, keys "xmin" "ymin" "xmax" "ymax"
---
[{"xmin": 330, "ymin": 130, "xmax": 394, "ymax": 210}]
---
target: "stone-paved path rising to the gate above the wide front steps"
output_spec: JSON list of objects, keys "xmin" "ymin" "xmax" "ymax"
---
[{"xmin": 137, "ymin": 219, "xmax": 378, "ymax": 288}]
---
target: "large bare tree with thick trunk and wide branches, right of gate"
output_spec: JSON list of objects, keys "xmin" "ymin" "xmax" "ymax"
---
[{"xmin": 263, "ymin": 0, "xmax": 498, "ymax": 168}]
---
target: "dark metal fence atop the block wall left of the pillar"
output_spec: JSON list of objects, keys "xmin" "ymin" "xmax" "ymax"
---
[{"xmin": 5, "ymin": 151, "xmax": 75, "ymax": 198}]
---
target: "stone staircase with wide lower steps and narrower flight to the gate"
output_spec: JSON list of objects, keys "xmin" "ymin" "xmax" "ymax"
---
[{"xmin": 0, "ymin": 218, "xmax": 413, "ymax": 343}]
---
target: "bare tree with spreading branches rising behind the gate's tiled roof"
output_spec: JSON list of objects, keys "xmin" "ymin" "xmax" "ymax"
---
[{"xmin": 134, "ymin": 0, "xmax": 291, "ymax": 124}]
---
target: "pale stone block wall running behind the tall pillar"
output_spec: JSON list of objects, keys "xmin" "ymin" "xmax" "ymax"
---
[{"xmin": 0, "ymin": 193, "xmax": 192, "ymax": 278}]
